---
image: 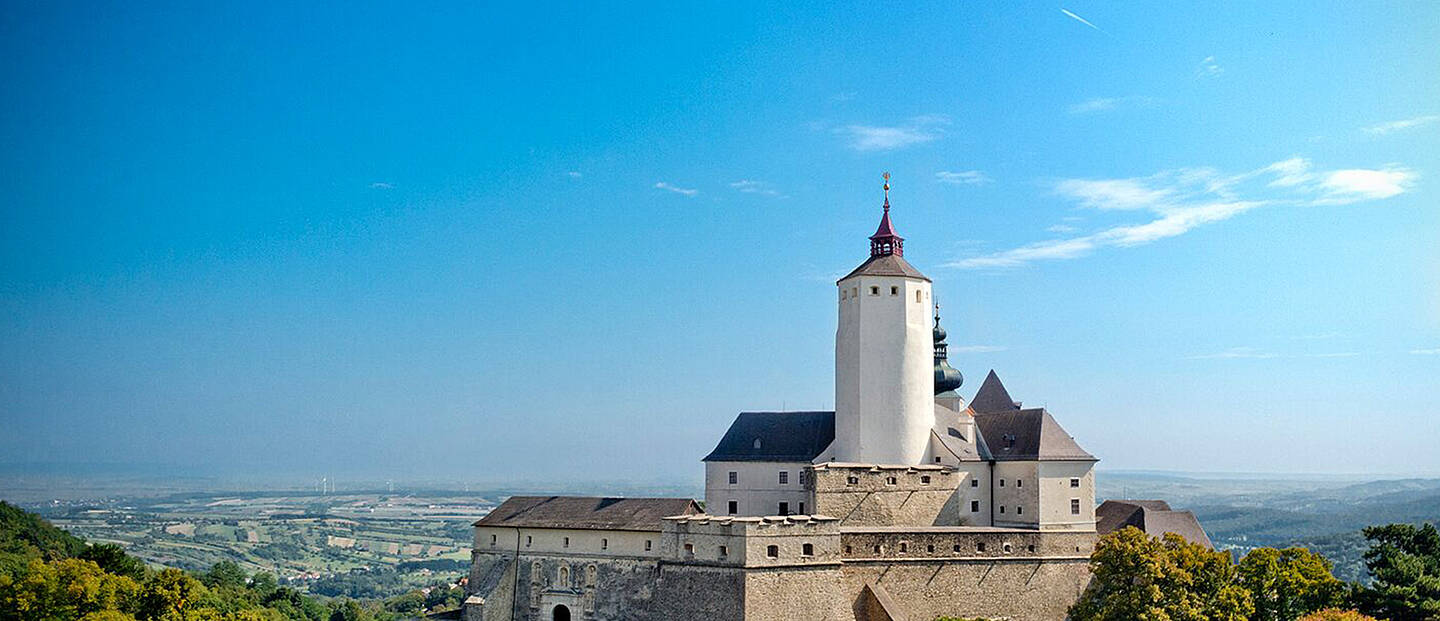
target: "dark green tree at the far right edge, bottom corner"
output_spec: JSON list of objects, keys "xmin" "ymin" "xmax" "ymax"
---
[{"xmin": 1356, "ymin": 524, "xmax": 1440, "ymax": 621}]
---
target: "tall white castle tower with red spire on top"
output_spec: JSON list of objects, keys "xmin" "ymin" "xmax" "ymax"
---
[{"xmin": 834, "ymin": 173, "xmax": 935, "ymax": 465}]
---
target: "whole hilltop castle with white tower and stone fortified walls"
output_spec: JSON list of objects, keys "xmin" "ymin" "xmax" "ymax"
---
[{"xmin": 464, "ymin": 174, "xmax": 1100, "ymax": 621}]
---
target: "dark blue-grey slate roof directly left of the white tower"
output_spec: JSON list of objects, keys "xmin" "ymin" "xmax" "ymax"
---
[{"xmin": 704, "ymin": 412, "xmax": 835, "ymax": 461}]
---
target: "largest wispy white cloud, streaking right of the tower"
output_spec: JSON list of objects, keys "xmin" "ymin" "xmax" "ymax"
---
[{"xmin": 946, "ymin": 157, "xmax": 1417, "ymax": 269}]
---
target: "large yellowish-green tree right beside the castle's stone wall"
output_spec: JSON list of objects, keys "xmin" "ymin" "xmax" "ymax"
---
[{"xmin": 1070, "ymin": 527, "xmax": 1251, "ymax": 621}]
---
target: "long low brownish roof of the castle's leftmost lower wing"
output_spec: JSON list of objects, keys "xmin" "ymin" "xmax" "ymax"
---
[{"xmin": 475, "ymin": 496, "xmax": 703, "ymax": 530}]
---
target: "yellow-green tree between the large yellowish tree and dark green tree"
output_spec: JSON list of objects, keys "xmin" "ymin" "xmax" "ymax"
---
[{"xmin": 1237, "ymin": 548, "xmax": 1345, "ymax": 621}]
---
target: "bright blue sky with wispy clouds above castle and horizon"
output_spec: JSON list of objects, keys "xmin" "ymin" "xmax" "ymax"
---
[{"xmin": 0, "ymin": 1, "xmax": 1440, "ymax": 481}]
